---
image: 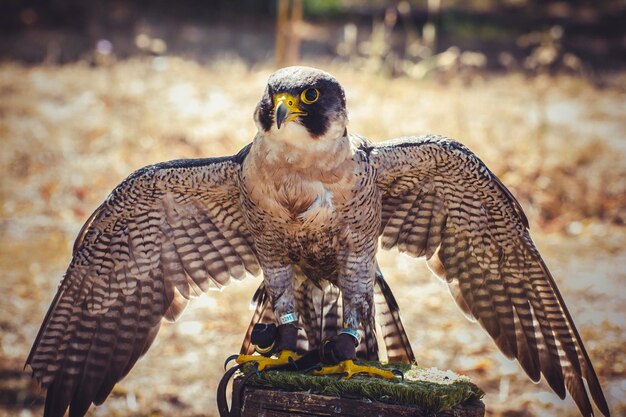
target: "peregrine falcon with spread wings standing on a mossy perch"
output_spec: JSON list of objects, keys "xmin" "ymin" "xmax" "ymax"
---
[{"xmin": 26, "ymin": 67, "xmax": 609, "ymax": 417}]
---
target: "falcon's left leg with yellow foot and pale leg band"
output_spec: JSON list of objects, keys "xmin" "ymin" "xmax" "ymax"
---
[{"xmin": 236, "ymin": 265, "xmax": 300, "ymax": 371}]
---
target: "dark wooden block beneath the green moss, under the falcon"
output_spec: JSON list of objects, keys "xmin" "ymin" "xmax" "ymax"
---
[{"xmin": 231, "ymin": 377, "xmax": 485, "ymax": 417}]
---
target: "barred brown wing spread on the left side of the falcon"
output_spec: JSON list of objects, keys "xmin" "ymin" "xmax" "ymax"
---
[{"xmin": 26, "ymin": 148, "xmax": 259, "ymax": 417}]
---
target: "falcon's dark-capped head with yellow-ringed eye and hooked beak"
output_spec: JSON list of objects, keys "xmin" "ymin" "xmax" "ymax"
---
[{"xmin": 254, "ymin": 67, "xmax": 348, "ymax": 145}]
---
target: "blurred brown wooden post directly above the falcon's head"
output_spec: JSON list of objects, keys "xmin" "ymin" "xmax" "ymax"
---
[{"xmin": 275, "ymin": 0, "xmax": 303, "ymax": 68}]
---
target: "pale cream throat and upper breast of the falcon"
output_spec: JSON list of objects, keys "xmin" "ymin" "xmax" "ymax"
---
[{"xmin": 244, "ymin": 117, "xmax": 355, "ymax": 224}]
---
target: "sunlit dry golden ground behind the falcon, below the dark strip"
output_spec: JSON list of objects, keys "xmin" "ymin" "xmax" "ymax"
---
[{"xmin": 0, "ymin": 58, "xmax": 626, "ymax": 416}]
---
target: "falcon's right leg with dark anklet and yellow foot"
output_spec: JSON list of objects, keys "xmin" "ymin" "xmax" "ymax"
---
[{"xmin": 314, "ymin": 252, "xmax": 394, "ymax": 379}]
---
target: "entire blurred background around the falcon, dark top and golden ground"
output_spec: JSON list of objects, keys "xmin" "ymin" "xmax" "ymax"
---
[{"xmin": 0, "ymin": 0, "xmax": 626, "ymax": 417}]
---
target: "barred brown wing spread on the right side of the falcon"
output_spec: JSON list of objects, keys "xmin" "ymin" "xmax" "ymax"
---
[{"xmin": 368, "ymin": 136, "xmax": 609, "ymax": 416}]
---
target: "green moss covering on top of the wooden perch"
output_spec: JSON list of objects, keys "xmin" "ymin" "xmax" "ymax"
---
[{"xmin": 236, "ymin": 362, "xmax": 484, "ymax": 413}]
